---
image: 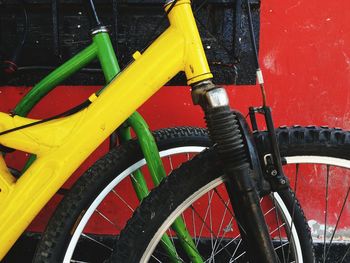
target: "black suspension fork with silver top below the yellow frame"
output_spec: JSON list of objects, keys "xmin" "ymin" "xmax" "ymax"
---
[{"xmin": 192, "ymin": 80, "xmax": 278, "ymax": 263}]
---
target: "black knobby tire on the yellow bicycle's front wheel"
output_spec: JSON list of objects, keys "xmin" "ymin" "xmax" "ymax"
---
[{"xmin": 112, "ymin": 150, "xmax": 313, "ymax": 262}]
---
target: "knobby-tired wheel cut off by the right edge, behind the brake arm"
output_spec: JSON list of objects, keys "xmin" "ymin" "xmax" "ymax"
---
[{"xmin": 256, "ymin": 126, "xmax": 350, "ymax": 263}]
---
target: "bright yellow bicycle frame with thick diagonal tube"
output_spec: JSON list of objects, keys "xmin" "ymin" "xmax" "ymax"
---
[{"xmin": 0, "ymin": 0, "xmax": 212, "ymax": 260}]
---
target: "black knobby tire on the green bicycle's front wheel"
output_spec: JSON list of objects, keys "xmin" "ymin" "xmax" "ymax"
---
[{"xmin": 34, "ymin": 127, "xmax": 210, "ymax": 262}]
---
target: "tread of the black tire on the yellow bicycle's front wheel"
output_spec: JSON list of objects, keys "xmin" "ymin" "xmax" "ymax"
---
[{"xmin": 110, "ymin": 150, "xmax": 314, "ymax": 263}]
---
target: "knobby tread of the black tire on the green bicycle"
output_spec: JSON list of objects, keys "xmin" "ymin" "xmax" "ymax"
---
[{"xmin": 33, "ymin": 127, "xmax": 210, "ymax": 262}]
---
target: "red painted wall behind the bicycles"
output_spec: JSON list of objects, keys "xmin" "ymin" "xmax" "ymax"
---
[{"xmin": 0, "ymin": 0, "xmax": 350, "ymax": 239}]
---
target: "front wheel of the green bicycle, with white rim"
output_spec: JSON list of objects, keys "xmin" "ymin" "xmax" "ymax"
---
[{"xmin": 34, "ymin": 127, "xmax": 210, "ymax": 262}]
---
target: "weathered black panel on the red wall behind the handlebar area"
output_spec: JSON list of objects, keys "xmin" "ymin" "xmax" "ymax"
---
[{"xmin": 0, "ymin": 0, "xmax": 260, "ymax": 85}]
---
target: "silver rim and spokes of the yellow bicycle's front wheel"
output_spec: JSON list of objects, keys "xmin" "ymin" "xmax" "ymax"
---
[{"xmin": 141, "ymin": 177, "xmax": 303, "ymax": 262}]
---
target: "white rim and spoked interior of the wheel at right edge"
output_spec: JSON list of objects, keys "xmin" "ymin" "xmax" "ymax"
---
[{"xmin": 285, "ymin": 155, "xmax": 350, "ymax": 263}]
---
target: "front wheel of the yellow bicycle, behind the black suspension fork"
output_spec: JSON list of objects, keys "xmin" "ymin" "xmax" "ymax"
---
[{"xmin": 112, "ymin": 150, "xmax": 313, "ymax": 262}]
